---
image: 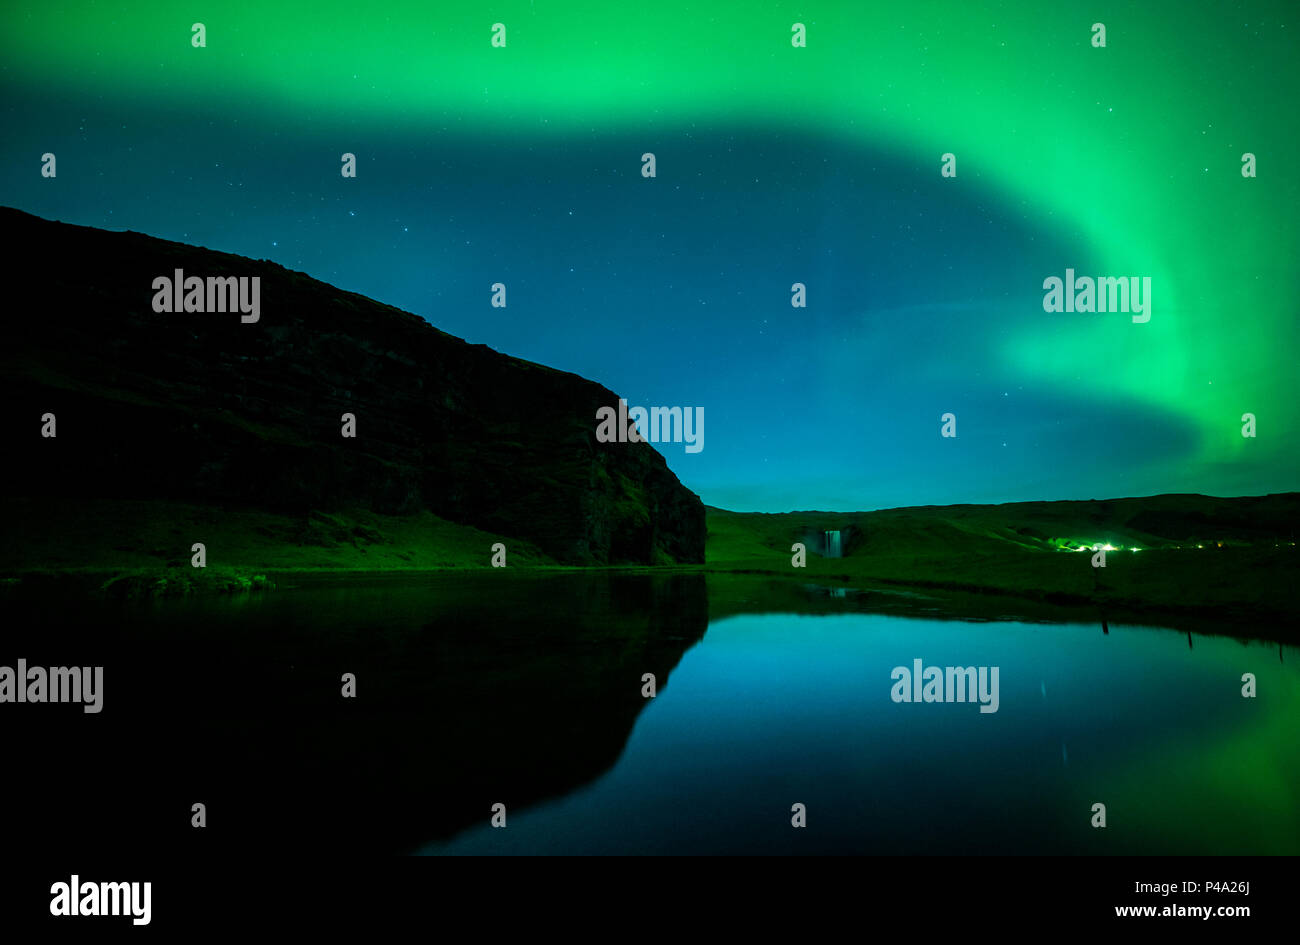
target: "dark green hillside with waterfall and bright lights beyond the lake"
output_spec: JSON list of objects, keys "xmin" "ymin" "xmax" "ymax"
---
[{"xmin": 706, "ymin": 493, "xmax": 1300, "ymax": 634}]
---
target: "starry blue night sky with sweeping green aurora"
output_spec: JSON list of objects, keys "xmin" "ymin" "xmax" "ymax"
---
[{"xmin": 0, "ymin": 0, "xmax": 1300, "ymax": 511}]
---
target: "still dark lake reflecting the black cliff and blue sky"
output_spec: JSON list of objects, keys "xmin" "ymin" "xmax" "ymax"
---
[{"xmin": 0, "ymin": 572, "xmax": 1300, "ymax": 855}]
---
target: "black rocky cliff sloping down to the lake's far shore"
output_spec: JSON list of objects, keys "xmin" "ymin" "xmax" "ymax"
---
[{"xmin": 0, "ymin": 208, "xmax": 705, "ymax": 564}]
